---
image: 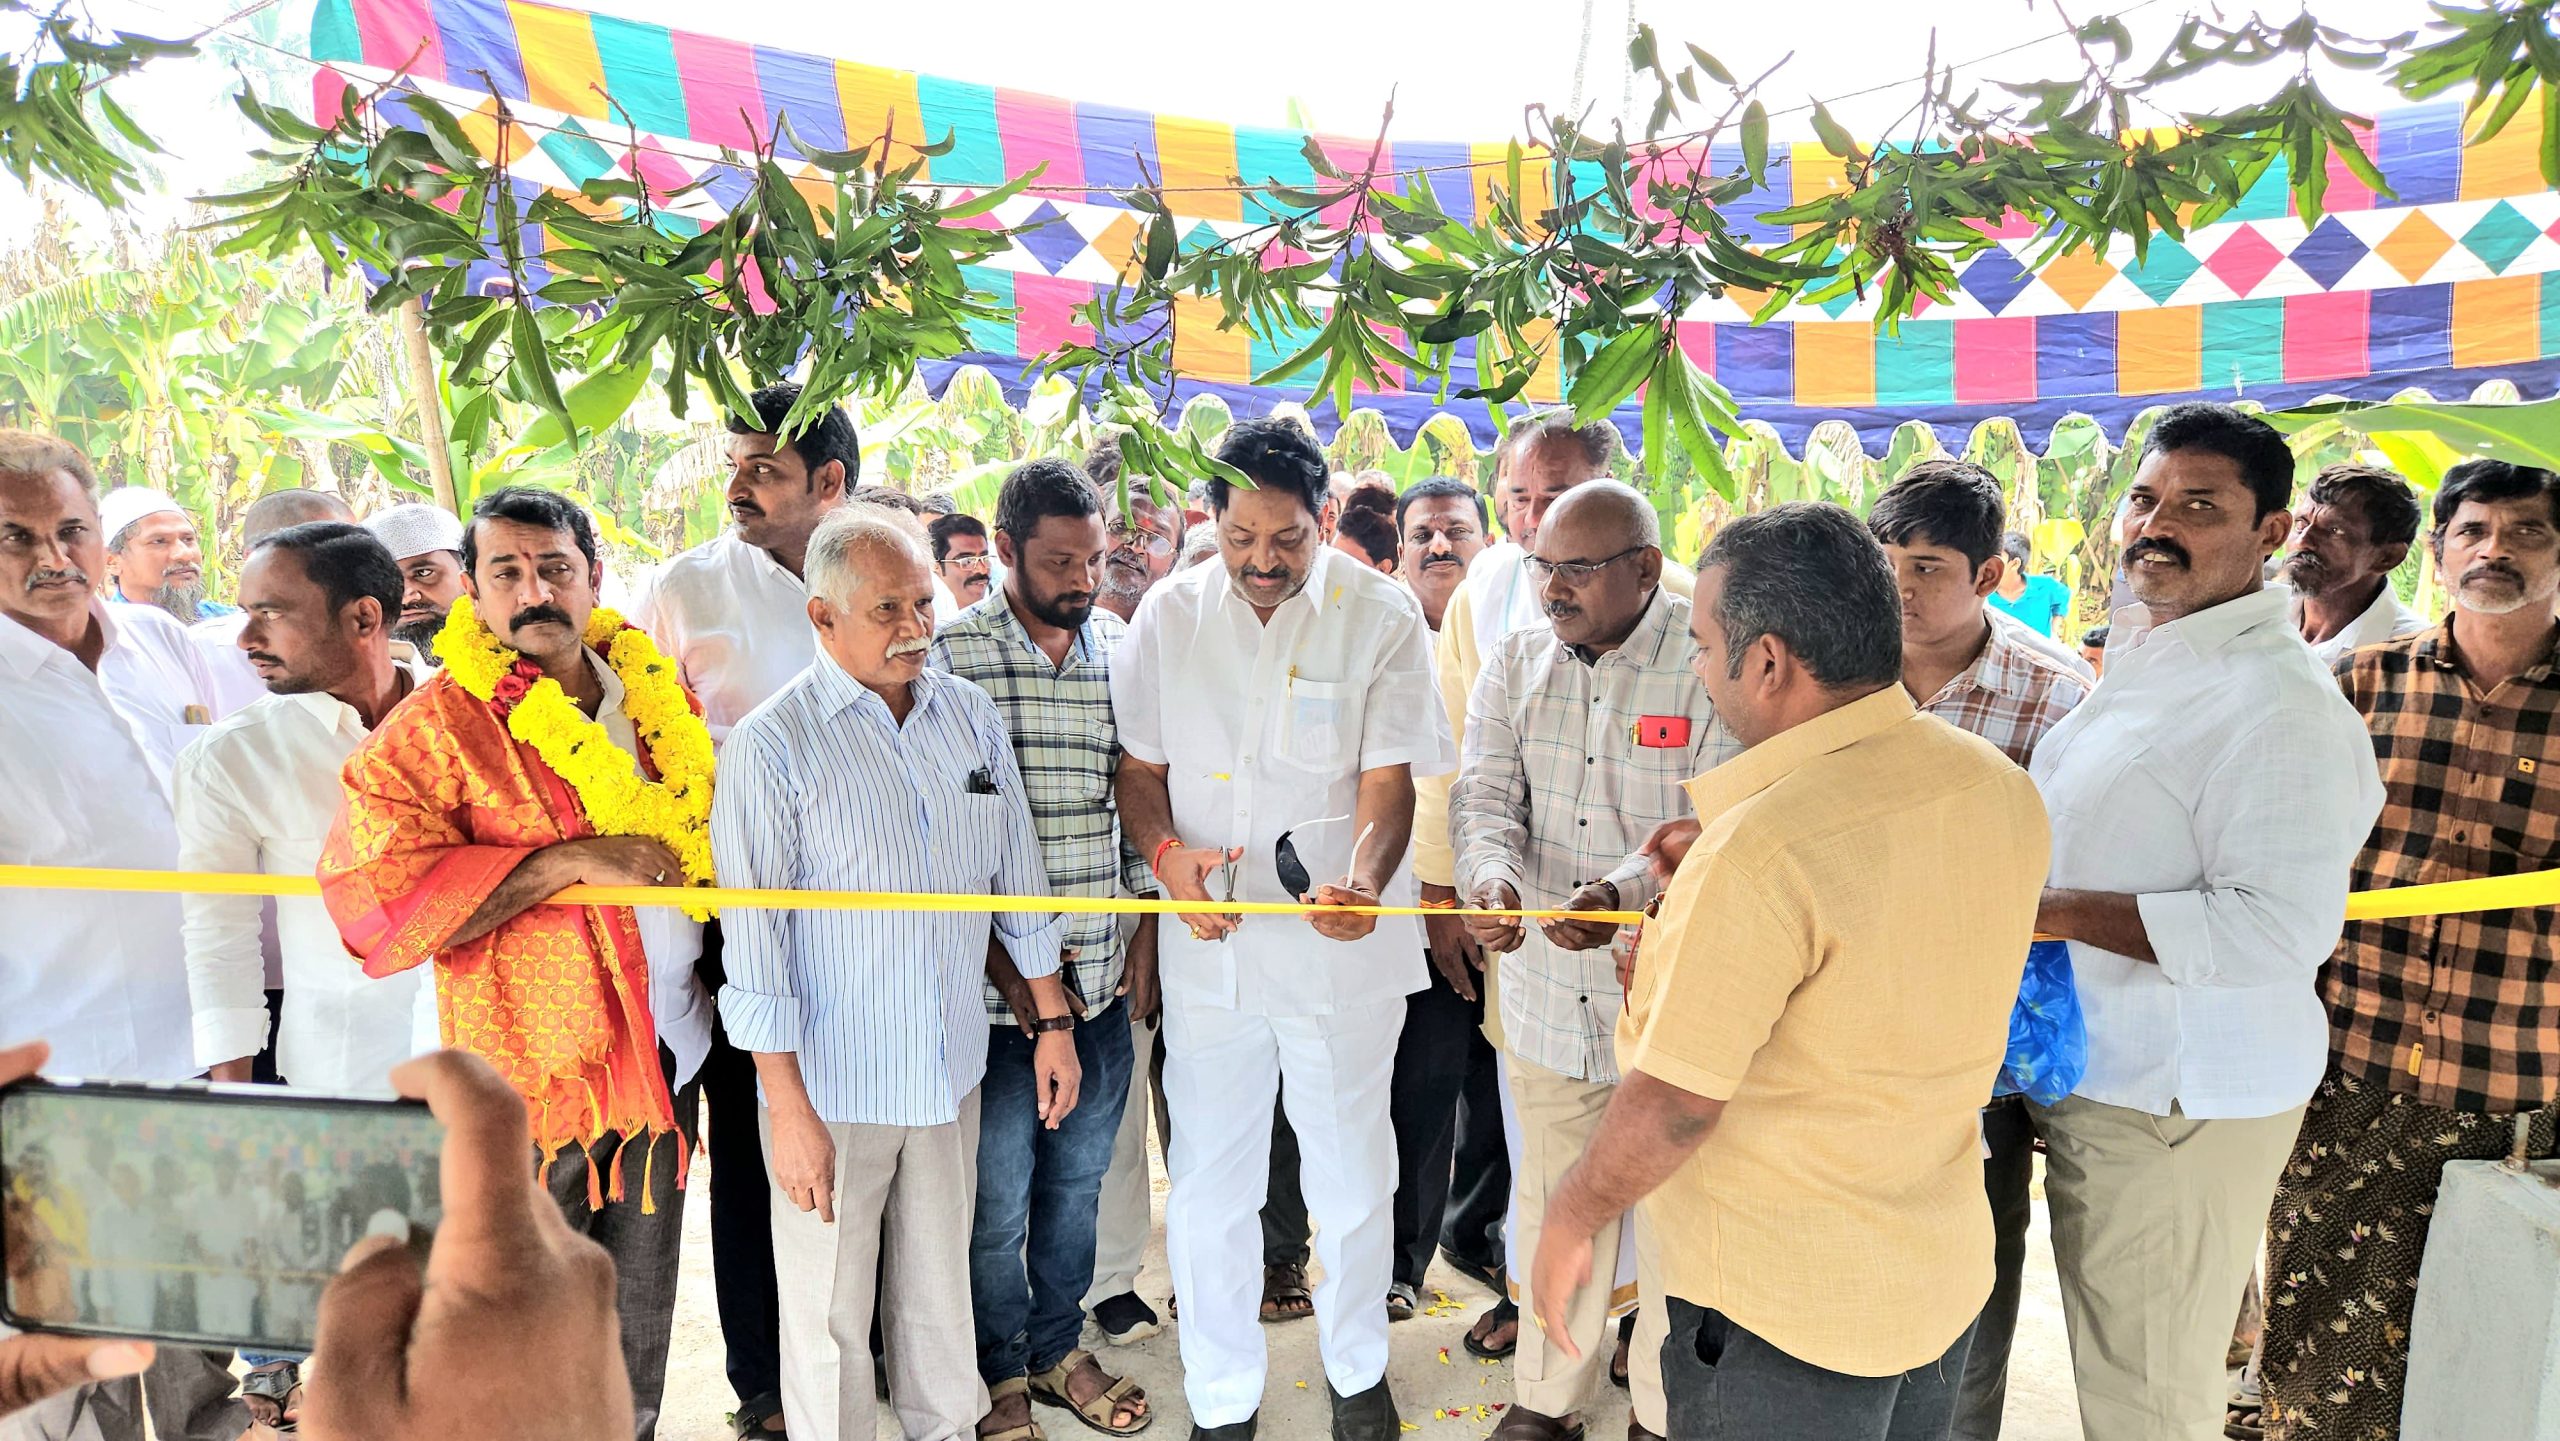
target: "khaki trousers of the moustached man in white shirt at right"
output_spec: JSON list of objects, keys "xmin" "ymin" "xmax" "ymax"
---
[{"xmin": 2035, "ymin": 1095, "xmax": 2301, "ymax": 1441}]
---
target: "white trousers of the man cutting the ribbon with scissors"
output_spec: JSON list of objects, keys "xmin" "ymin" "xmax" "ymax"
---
[{"xmin": 1165, "ymin": 998, "xmax": 1405, "ymax": 1426}]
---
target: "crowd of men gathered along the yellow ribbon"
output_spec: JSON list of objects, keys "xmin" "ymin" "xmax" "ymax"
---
[{"xmin": 0, "ymin": 386, "xmax": 2560, "ymax": 1441}]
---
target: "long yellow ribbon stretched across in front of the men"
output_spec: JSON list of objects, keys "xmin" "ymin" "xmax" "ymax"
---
[{"xmin": 0, "ymin": 865, "xmax": 2560, "ymax": 927}]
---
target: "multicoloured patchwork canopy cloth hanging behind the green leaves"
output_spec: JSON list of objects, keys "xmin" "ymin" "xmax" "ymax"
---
[{"xmin": 312, "ymin": 0, "xmax": 2560, "ymax": 448}]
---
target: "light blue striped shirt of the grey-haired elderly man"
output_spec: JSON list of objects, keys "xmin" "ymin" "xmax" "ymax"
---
[{"xmin": 712, "ymin": 650, "xmax": 1065, "ymax": 1126}]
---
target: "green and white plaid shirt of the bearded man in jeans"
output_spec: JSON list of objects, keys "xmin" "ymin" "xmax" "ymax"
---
[{"xmin": 929, "ymin": 589, "xmax": 1155, "ymax": 1021}]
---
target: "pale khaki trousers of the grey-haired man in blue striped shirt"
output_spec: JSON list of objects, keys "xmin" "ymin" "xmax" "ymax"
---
[{"xmin": 758, "ymin": 1090, "xmax": 988, "ymax": 1441}]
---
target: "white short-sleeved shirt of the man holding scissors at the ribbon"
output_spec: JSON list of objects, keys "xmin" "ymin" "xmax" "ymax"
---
[{"xmin": 1111, "ymin": 548, "xmax": 1457, "ymax": 1016}]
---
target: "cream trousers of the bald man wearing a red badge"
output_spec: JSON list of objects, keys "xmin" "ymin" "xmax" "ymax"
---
[{"xmin": 1503, "ymin": 1055, "xmax": 1669, "ymax": 1436}]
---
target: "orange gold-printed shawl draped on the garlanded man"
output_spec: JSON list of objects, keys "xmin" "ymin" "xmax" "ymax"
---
[{"xmin": 320, "ymin": 673, "xmax": 676, "ymax": 1162}]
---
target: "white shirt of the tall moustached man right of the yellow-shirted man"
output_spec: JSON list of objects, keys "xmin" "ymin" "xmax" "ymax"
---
[{"xmin": 2030, "ymin": 586, "xmax": 2383, "ymax": 1121}]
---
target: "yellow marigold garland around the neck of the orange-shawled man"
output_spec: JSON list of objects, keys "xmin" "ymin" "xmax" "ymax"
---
[{"xmin": 435, "ymin": 596, "xmax": 712, "ymax": 919}]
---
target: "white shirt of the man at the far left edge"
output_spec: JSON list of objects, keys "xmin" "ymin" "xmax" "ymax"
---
[{"xmin": 0, "ymin": 601, "xmax": 202, "ymax": 1080}]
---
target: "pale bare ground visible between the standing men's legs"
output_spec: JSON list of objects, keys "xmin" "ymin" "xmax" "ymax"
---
[{"xmin": 658, "ymin": 1165, "xmax": 2081, "ymax": 1441}]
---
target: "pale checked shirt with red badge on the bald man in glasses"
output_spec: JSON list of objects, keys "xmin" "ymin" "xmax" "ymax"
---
[{"xmin": 1449, "ymin": 589, "xmax": 1743, "ymax": 1083}]
